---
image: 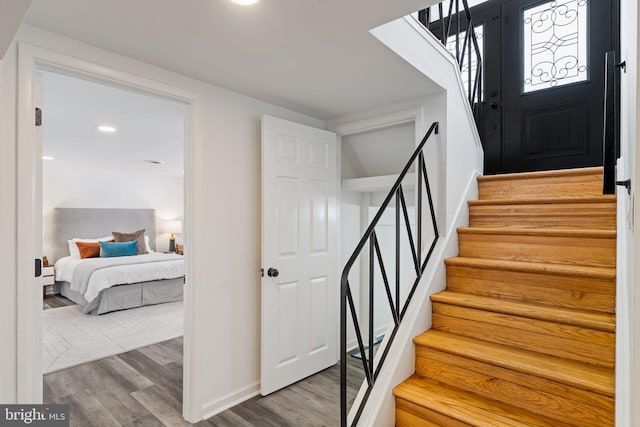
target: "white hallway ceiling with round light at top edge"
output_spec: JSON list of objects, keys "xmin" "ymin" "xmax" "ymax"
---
[{"xmin": 26, "ymin": 0, "xmax": 439, "ymax": 119}]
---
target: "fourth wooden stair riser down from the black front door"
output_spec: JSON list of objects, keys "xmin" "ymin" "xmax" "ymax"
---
[{"xmin": 447, "ymin": 265, "xmax": 616, "ymax": 313}]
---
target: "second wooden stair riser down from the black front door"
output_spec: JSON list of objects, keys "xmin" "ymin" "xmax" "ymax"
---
[{"xmin": 469, "ymin": 203, "xmax": 616, "ymax": 230}]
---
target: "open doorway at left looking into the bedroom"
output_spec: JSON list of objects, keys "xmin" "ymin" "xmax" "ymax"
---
[{"xmin": 34, "ymin": 70, "xmax": 188, "ymax": 425}]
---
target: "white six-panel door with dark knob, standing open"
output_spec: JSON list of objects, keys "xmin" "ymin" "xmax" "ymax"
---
[{"xmin": 261, "ymin": 116, "xmax": 338, "ymax": 395}]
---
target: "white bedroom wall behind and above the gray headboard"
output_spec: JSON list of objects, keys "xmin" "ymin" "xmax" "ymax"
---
[{"xmin": 42, "ymin": 160, "xmax": 184, "ymax": 262}]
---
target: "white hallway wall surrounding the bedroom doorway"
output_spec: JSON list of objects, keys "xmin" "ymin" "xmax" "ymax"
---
[{"xmin": 0, "ymin": 26, "xmax": 324, "ymax": 416}]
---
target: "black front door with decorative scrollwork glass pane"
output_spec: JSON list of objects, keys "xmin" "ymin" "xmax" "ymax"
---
[{"xmin": 502, "ymin": 0, "xmax": 618, "ymax": 173}]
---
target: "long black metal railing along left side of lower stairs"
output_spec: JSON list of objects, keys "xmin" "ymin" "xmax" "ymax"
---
[{"xmin": 340, "ymin": 122, "xmax": 438, "ymax": 427}]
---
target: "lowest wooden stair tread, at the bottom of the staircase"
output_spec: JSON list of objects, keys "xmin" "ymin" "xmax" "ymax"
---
[{"xmin": 393, "ymin": 375, "xmax": 564, "ymax": 427}]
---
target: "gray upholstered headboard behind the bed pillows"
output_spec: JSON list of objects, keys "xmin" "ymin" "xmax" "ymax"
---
[{"xmin": 52, "ymin": 208, "xmax": 156, "ymax": 261}]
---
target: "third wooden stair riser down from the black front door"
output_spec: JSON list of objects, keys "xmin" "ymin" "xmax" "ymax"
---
[{"xmin": 458, "ymin": 233, "xmax": 616, "ymax": 268}]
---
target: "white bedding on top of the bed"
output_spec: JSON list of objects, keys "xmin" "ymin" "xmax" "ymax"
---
[{"xmin": 55, "ymin": 253, "xmax": 184, "ymax": 303}]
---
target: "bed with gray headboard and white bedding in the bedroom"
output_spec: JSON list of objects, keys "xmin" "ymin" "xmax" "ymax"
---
[{"xmin": 53, "ymin": 208, "xmax": 184, "ymax": 314}]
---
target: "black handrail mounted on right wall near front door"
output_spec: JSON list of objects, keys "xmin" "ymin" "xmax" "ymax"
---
[{"xmin": 602, "ymin": 51, "xmax": 618, "ymax": 194}]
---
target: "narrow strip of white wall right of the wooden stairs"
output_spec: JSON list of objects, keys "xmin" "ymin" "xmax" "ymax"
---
[{"xmin": 616, "ymin": 0, "xmax": 640, "ymax": 426}]
